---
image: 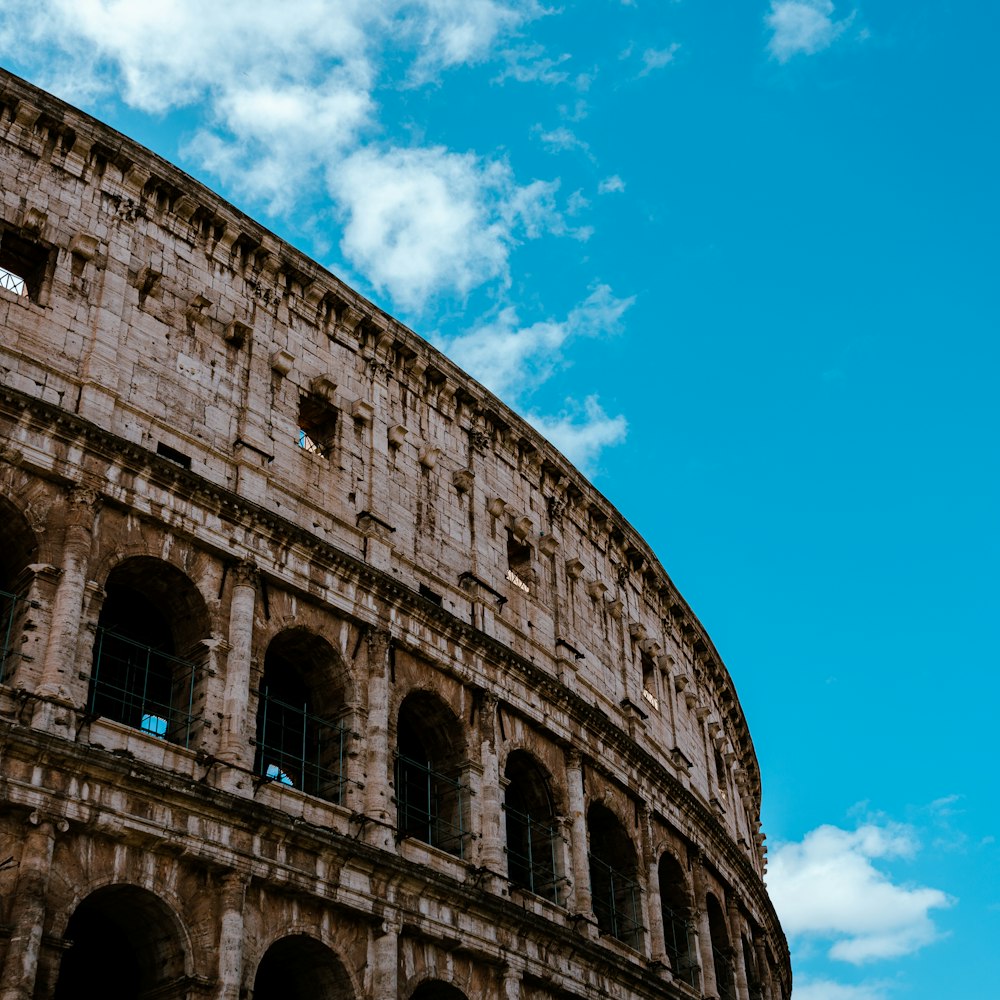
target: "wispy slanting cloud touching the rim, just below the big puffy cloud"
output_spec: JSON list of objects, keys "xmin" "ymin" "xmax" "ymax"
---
[{"xmin": 442, "ymin": 285, "xmax": 634, "ymax": 403}]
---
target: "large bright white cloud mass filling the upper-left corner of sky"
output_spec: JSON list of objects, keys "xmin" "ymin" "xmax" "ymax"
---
[{"xmin": 0, "ymin": 0, "xmax": 554, "ymax": 309}]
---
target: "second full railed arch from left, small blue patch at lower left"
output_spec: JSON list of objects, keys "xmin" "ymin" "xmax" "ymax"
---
[{"xmin": 255, "ymin": 629, "xmax": 347, "ymax": 803}]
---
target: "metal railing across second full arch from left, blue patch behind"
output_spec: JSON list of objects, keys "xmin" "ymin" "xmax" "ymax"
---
[{"xmin": 255, "ymin": 688, "xmax": 347, "ymax": 805}]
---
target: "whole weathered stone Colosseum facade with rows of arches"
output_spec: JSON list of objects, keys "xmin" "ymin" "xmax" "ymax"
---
[{"xmin": 0, "ymin": 73, "xmax": 791, "ymax": 1000}]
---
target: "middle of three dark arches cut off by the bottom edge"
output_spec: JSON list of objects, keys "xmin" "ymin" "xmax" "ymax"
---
[{"xmin": 253, "ymin": 934, "xmax": 354, "ymax": 1000}]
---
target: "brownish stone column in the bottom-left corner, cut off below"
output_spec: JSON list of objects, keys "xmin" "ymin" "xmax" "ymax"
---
[{"xmin": 0, "ymin": 812, "xmax": 67, "ymax": 1000}]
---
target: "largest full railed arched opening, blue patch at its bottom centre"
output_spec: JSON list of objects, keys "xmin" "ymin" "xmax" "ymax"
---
[{"xmin": 89, "ymin": 557, "xmax": 208, "ymax": 746}]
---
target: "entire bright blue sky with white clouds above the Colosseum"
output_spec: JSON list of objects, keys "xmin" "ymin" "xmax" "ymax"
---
[{"xmin": 0, "ymin": 0, "xmax": 1000, "ymax": 1000}]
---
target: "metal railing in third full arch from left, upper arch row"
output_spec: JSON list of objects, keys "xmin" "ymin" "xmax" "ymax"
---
[{"xmin": 396, "ymin": 753, "xmax": 468, "ymax": 858}]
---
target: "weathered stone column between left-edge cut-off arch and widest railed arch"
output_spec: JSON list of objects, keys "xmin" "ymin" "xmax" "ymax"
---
[{"xmin": 32, "ymin": 486, "xmax": 100, "ymax": 728}]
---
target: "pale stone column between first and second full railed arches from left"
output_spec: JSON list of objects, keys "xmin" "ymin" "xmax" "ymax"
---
[{"xmin": 219, "ymin": 561, "xmax": 259, "ymax": 770}]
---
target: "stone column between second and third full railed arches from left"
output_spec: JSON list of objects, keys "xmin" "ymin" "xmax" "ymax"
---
[{"xmin": 359, "ymin": 629, "xmax": 396, "ymax": 851}]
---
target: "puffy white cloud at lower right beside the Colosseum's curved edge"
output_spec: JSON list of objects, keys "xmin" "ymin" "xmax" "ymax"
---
[{"xmin": 768, "ymin": 823, "xmax": 954, "ymax": 965}]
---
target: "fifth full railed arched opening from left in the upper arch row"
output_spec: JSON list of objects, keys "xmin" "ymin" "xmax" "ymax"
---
[{"xmin": 587, "ymin": 802, "xmax": 643, "ymax": 951}]
